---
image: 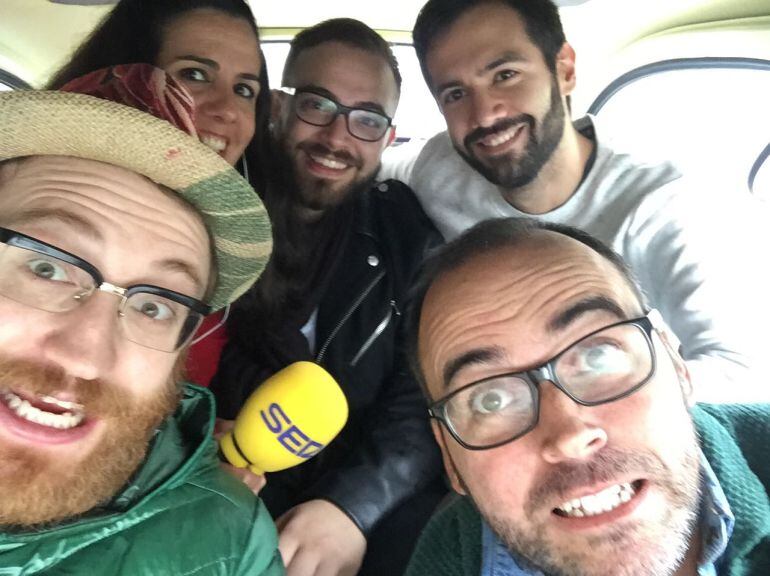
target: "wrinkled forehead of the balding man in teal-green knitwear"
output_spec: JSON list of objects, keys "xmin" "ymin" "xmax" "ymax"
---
[{"xmin": 420, "ymin": 243, "xmax": 630, "ymax": 392}]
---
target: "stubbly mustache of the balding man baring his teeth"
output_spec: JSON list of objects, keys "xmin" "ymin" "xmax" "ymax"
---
[{"xmin": 525, "ymin": 448, "xmax": 670, "ymax": 515}]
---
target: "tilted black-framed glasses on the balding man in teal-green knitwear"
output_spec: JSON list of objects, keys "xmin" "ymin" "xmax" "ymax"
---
[{"xmin": 428, "ymin": 310, "xmax": 663, "ymax": 450}]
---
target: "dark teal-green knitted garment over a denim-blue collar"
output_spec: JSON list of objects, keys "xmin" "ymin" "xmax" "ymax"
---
[{"xmin": 406, "ymin": 404, "xmax": 770, "ymax": 576}]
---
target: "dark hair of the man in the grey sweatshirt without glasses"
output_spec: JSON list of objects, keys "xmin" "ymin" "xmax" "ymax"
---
[{"xmin": 412, "ymin": 0, "xmax": 566, "ymax": 91}]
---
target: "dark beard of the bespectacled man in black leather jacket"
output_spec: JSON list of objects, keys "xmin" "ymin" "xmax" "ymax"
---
[{"xmin": 279, "ymin": 143, "xmax": 380, "ymax": 211}]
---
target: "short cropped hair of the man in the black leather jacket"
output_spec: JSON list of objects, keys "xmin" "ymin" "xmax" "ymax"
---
[{"xmin": 283, "ymin": 18, "xmax": 401, "ymax": 91}]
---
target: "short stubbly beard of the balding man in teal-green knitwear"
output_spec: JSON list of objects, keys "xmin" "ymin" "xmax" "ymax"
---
[{"xmin": 456, "ymin": 430, "xmax": 701, "ymax": 576}]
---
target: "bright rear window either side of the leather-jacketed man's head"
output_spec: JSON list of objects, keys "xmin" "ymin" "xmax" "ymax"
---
[{"xmin": 262, "ymin": 40, "xmax": 445, "ymax": 143}]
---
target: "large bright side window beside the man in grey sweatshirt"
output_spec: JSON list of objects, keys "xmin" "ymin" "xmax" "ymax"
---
[{"xmin": 598, "ymin": 63, "xmax": 770, "ymax": 198}]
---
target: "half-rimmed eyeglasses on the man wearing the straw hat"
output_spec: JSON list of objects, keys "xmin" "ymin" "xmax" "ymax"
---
[{"xmin": 0, "ymin": 228, "xmax": 210, "ymax": 352}]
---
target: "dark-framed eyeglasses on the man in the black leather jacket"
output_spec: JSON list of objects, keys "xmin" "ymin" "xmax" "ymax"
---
[{"xmin": 281, "ymin": 87, "xmax": 393, "ymax": 142}]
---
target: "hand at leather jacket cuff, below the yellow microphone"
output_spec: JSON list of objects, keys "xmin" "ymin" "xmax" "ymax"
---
[{"xmin": 276, "ymin": 500, "xmax": 366, "ymax": 576}]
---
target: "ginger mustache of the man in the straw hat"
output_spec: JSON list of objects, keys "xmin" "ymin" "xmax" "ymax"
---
[{"xmin": 0, "ymin": 356, "xmax": 134, "ymax": 418}]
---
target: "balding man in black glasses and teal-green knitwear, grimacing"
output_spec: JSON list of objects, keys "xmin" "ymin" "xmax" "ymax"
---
[{"xmin": 407, "ymin": 218, "xmax": 770, "ymax": 576}]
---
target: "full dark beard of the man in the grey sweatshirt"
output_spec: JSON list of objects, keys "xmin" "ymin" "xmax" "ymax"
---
[{"xmin": 455, "ymin": 77, "xmax": 565, "ymax": 190}]
